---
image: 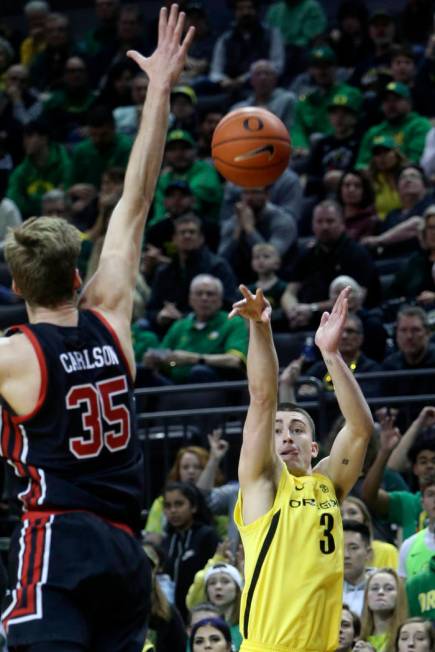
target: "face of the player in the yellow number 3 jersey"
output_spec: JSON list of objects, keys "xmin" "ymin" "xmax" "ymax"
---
[{"xmin": 275, "ymin": 411, "xmax": 319, "ymax": 475}]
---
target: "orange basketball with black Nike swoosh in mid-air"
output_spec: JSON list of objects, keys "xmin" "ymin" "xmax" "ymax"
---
[{"xmin": 211, "ymin": 106, "xmax": 291, "ymax": 188}]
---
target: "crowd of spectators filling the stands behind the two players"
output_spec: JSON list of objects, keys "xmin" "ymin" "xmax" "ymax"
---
[{"xmin": 0, "ymin": 0, "xmax": 435, "ymax": 652}]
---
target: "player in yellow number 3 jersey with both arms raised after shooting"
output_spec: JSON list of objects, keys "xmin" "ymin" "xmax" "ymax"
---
[{"xmin": 230, "ymin": 286, "xmax": 373, "ymax": 652}]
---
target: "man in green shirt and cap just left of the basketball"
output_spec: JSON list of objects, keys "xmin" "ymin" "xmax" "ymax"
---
[{"xmin": 150, "ymin": 129, "xmax": 222, "ymax": 224}]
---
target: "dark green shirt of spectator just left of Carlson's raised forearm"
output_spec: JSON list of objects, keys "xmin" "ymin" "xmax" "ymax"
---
[{"xmin": 71, "ymin": 134, "xmax": 133, "ymax": 188}]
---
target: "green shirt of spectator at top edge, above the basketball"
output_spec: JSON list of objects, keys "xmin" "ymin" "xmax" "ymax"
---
[{"xmin": 266, "ymin": 0, "xmax": 327, "ymax": 47}]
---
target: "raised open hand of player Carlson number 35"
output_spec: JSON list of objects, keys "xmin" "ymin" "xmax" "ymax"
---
[{"xmin": 127, "ymin": 4, "xmax": 195, "ymax": 87}]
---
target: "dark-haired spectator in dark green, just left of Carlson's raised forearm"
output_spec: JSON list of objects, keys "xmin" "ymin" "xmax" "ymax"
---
[{"xmin": 71, "ymin": 106, "xmax": 132, "ymax": 188}]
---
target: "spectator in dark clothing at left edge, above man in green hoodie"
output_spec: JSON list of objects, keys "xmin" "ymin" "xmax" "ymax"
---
[{"xmin": 0, "ymin": 64, "xmax": 43, "ymax": 125}]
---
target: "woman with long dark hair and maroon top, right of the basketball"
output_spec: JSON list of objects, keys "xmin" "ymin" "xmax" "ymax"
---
[{"xmin": 337, "ymin": 169, "xmax": 379, "ymax": 240}]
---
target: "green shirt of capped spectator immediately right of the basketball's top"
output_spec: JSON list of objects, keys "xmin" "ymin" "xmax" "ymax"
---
[{"xmin": 290, "ymin": 84, "xmax": 361, "ymax": 150}]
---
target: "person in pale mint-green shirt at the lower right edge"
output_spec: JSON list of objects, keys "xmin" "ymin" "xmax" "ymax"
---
[{"xmin": 398, "ymin": 472, "xmax": 435, "ymax": 579}]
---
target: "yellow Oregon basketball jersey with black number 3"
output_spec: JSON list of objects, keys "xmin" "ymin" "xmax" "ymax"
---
[{"xmin": 234, "ymin": 465, "xmax": 343, "ymax": 652}]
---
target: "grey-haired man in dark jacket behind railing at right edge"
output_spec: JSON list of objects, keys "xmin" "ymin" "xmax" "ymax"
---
[{"xmin": 382, "ymin": 306, "xmax": 435, "ymax": 414}]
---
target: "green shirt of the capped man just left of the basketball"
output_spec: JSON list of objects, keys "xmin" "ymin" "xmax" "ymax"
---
[{"xmin": 150, "ymin": 161, "xmax": 223, "ymax": 224}]
